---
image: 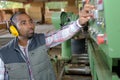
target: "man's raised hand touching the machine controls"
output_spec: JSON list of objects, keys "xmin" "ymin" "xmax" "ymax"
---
[{"xmin": 79, "ymin": 4, "xmax": 95, "ymax": 25}]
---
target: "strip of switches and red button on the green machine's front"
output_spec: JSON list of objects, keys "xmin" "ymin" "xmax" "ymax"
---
[{"xmin": 89, "ymin": 0, "xmax": 107, "ymax": 44}]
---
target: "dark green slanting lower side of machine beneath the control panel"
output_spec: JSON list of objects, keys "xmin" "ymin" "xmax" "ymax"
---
[{"xmin": 88, "ymin": 41, "xmax": 112, "ymax": 80}]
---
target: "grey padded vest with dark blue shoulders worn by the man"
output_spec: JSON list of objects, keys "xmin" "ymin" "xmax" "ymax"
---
[{"xmin": 0, "ymin": 34, "xmax": 56, "ymax": 80}]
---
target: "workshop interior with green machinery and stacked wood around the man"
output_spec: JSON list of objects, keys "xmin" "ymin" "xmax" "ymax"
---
[{"xmin": 0, "ymin": 0, "xmax": 120, "ymax": 80}]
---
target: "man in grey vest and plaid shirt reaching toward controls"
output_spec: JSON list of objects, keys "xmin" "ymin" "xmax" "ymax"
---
[{"xmin": 0, "ymin": 4, "xmax": 93, "ymax": 80}]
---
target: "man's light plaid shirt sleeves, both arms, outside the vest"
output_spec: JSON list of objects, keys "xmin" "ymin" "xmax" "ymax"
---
[{"xmin": 0, "ymin": 20, "xmax": 82, "ymax": 80}]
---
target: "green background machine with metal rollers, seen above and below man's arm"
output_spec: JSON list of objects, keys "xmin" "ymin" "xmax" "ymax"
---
[{"xmin": 52, "ymin": 12, "xmax": 90, "ymax": 80}]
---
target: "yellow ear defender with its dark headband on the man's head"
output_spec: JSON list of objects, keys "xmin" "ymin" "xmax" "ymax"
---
[{"xmin": 9, "ymin": 15, "xmax": 19, "ymax": 37}]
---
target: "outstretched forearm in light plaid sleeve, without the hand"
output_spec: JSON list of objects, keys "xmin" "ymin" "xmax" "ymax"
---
[{"xmin": 46, "ymin": 21, "xmax": 81, "ymax": 47}]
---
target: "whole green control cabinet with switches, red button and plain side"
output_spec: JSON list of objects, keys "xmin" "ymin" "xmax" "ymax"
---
[{"xmin": 89, "ymin": 0, "xmax": 120, "ymax": 58}]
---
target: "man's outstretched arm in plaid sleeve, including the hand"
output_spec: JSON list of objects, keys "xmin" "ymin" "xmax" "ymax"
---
[{"xmin": 46, "ymin": 4, "xmax": 94, "ymax": 47}]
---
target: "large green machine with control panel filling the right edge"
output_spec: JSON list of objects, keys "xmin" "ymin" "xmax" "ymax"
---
[{"xmin": 87, "ymin": 0, "xmax": 120, "ymax": 80}]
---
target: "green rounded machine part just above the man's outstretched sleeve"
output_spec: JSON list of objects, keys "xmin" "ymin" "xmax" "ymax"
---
[{"xmin": 52, "ymin": 12, "xmax": 78, "ymax": 30}]
